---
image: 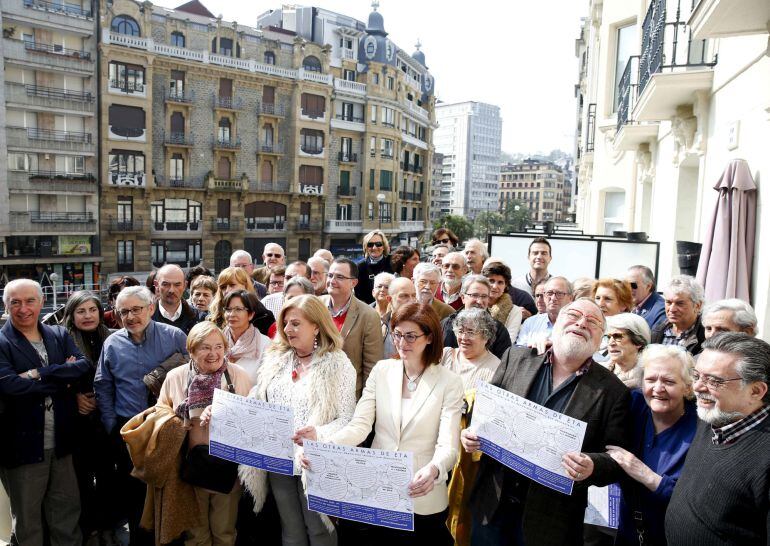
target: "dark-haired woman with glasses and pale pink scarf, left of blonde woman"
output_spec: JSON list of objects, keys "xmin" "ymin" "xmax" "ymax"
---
[{"xmin": 223, "ymin": 290, "xmax": 270, "ymax": 384}]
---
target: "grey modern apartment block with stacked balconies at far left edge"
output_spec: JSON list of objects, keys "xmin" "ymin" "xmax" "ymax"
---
[{"xmin": 0, "ymin": 0, "xmax": 102, "ymax": 287}]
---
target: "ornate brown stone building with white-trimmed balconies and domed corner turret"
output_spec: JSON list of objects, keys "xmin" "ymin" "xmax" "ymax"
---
[{"xmin": 99, "ymin": 0, "xmax": 433, "ymax": 271}]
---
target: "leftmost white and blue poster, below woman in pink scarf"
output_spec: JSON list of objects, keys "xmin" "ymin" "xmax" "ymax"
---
[{"xmin": 209, "ymin": 389, "xmax": 294, "ymax": 475}]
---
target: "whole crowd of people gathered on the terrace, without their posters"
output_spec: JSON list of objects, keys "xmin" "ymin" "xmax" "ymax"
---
[{"xmin": 0, "ymin": 228, "xmax": 770, "ymax": 546}]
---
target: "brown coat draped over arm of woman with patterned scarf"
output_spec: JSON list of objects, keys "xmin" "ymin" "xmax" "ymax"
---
[{"xmin": 120, "ymin": 406, "xmax": 203, "ymax": 544}]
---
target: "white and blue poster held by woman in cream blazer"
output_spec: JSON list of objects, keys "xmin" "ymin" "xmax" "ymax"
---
[{"xmin": 304, "ymin": 440, "xmax": 414, "ymax": 531}]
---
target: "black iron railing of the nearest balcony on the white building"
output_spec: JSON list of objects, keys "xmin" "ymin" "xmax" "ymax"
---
[{"xmin": 639, "ymin": 0, "xmax": 717, "ymax": 94}]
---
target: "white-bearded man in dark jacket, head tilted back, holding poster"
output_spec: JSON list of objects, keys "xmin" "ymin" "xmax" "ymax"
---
[{"xmin": 461, "ymin": 300, "xmax": 631, "ymax": 546}]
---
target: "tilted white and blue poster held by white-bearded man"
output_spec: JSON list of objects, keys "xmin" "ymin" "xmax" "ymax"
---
[{"xmin": 471, "ymin": 381, "xmax": 586, "ymax": 495}]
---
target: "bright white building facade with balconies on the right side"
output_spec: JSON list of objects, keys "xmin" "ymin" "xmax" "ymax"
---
[{"xmin": 575, "ymin": 0, "xmax": 770, "ymax": 338}]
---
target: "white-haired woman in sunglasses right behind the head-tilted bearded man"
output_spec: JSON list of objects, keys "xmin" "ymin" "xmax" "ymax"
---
[{"xmin": 602, "ymin": 313, "xmax": 651, "ymax": 389}]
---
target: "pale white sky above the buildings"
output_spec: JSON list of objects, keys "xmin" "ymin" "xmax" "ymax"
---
[{"xmin": 153, "ymin": 0, "xmax": 588, "ymax": 153}]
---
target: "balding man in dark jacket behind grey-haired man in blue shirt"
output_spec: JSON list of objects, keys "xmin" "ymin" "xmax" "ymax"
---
[{"xmin": 152, "ymin": 264, "xmax": 206, "ymax": 335}]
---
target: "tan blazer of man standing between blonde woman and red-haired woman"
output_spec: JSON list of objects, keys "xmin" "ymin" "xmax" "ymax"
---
[{"xmin": 321, "ymin": 295, "xmax": 383, "ymax": 399}]
